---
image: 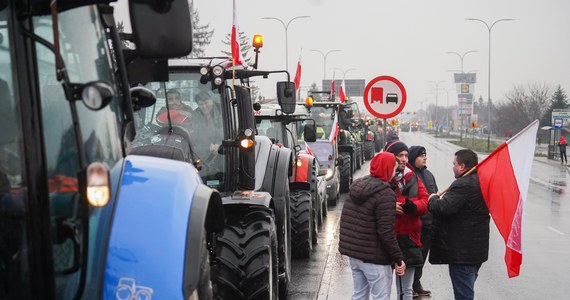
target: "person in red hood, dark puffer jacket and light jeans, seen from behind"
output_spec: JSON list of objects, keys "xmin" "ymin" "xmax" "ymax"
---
[{"xmin": 339, "ymin": 152, "xmax": 406, "ymax": 299}]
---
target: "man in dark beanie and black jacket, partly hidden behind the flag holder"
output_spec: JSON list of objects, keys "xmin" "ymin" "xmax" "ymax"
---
[{"xmin": 409, "ymin": 146, "xmax": 438, "ymax": 296}]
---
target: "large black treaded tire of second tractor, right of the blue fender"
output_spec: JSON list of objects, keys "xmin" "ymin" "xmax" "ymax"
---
[{"xmin": 214, "ymin": 206, "xmax": 279, "ymax": 300}]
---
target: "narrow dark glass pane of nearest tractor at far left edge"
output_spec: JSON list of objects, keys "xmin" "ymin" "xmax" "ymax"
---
[{"xmin": 0, "ymin": 8, "xmax": 31, "ymax": 299}]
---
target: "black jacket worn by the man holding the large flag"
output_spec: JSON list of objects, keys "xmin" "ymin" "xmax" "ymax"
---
[{"xmin": 428, "ymin": 172, "xmax": 490, "ymax": 264}]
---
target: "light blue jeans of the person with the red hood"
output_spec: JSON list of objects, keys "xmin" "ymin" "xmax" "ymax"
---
[{"xmin": 349, "ymin": 257, "xmax": 392, "ymax": 300}]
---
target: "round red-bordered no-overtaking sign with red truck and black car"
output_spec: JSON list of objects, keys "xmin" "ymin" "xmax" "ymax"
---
[{"xmin": 364, "ymin": 76, "xmax": 406, "ymax": 119}]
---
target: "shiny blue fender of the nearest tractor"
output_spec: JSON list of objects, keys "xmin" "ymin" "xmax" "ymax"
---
[{"xmin": 102, "ymin": 155, "xmax": 204, "ymax": 299}]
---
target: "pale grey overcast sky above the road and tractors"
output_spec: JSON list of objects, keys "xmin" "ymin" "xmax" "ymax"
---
[{"xmin": 112, "ymin": 0, "xmax": 570, "ymax": 111}]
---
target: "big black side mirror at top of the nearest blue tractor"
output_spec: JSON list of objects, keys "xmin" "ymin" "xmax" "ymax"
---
[{"xmin": 129, "ymin": 0, "xmax": 192, "ymax": 59}]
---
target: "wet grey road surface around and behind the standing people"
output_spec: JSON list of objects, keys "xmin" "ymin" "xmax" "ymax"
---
[{"xmin": 287, "ymin": 132, "xmax": 570, "ymax": 300}]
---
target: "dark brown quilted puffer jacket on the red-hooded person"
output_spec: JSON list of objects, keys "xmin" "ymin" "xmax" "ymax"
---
[{"xmin": 339, "ymin": 176, "xmax": 403, "ymax": 265}]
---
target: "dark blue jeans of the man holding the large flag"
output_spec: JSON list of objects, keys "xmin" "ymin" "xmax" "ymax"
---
[{"xmin": 449, "ymin": 264, "xmax": 481, "ymax": 300}]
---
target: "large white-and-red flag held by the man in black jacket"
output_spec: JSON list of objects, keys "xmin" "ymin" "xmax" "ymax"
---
[{"xmin": 477, "ymin": 120, "xmax": 538, "ymax": 278}]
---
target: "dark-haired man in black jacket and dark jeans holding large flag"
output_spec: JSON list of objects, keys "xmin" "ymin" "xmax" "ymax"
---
[{"xmin": 428, "ymin": 149, "xmax": 491, "ymax": 299}]
